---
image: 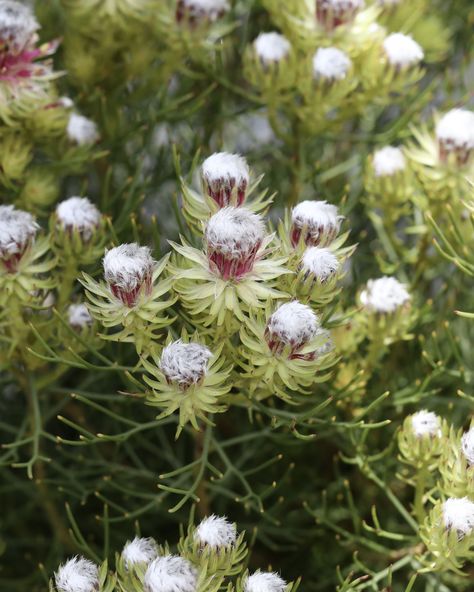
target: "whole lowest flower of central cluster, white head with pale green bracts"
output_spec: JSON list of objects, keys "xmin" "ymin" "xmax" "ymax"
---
[{"xmin": 143, "ymin": 336, "xmax": 231, "ymax": 437}]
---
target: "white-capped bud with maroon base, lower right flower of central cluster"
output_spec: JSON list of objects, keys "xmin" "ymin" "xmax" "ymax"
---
[{"xmin": 265, "ymin": 300, "xmax": 321, "ymax": 359}]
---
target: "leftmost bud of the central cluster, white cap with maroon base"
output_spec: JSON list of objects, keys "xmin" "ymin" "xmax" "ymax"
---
[{"xmin": 103, "ymin": 243, "xmax": 155, "ymax": 308}]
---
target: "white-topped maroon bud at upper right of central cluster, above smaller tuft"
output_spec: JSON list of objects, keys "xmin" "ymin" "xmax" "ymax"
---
[{"xmin": 290, "ymin": 201, "xmax": 342, "ymax": 247}]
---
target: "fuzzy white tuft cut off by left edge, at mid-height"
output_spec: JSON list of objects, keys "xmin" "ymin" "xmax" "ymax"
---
[{"xmin": 0, "ymin": 206, "xmax": 39, "ymax": 257}]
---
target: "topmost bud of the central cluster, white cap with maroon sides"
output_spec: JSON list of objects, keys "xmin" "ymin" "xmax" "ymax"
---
[{"xmin": 201, "ymin": 152, "xmax": 249, "ymax": 208}]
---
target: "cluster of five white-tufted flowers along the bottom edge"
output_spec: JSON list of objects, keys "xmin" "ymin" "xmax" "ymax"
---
[{"xmin": 50, "ymin": 515, "xmax": 298, "ymax": 592}]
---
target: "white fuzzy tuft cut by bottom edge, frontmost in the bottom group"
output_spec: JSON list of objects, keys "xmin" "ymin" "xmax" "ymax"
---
[{"xmin": 144, "ymin": 555, "xmax": 197, "ymax": 592}]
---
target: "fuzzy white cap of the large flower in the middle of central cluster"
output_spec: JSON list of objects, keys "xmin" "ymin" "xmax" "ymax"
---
[{"xmin": 206, "ymin": 207, "xmax": 265, "ymax": 259}]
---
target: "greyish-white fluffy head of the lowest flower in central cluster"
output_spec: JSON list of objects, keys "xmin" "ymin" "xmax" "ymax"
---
[{"xmin": 160, "ymin": 339, "xmax": 212, "ymax": 388}]
